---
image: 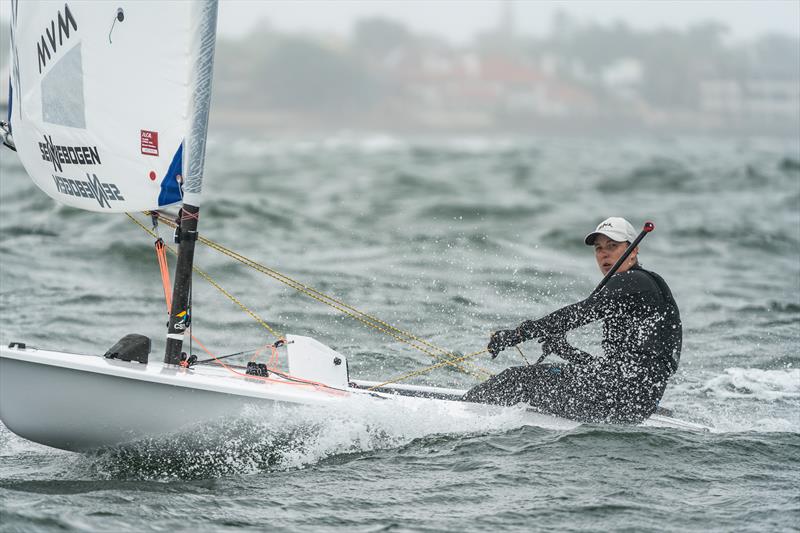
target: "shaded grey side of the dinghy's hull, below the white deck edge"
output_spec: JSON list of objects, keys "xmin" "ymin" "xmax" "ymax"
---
[{"xmin": 0, "ymin": 350, "xmax": 267, "ymax": 451}]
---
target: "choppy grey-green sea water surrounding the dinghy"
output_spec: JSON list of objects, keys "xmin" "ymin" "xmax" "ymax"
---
[{"xmin": 0, "ymin": 134, "xmax": 800, "ymax": 531}]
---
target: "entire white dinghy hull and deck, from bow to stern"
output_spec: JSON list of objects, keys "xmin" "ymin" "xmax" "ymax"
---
[{"xmin": 0, "ymin": 337, "xmax": 705, "ymax": 451}]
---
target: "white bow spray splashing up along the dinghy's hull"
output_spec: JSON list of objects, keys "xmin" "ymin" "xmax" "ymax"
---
[{"xmin": 76, "ymin": 394, "xmax": 536, "ymax": 480}]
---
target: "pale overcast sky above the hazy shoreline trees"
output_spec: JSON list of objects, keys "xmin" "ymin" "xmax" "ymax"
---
[{"xmin": 219, "ymin": 0, "xmax": 800, "ymax": 43}]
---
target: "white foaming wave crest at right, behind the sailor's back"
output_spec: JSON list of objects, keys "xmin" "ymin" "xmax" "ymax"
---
[{"xmin": 701, "ymin": 367, "xmax": 800, "ymax": 402}]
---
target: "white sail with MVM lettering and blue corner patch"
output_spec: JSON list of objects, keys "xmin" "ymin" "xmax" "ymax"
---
[{"xmin": 9, "ymin": 0, "xmax": 217, "ymax": 212}]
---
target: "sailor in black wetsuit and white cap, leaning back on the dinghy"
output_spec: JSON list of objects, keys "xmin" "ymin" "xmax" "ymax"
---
[{"xmin": 463, "ymin": 217, "xmax": 682, "ymax": 423}]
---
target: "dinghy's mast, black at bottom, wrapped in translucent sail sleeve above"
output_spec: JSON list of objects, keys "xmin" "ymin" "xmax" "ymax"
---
[{"xmin": 164, "ymin": 0, "xmax": 217, "ymax": 365}]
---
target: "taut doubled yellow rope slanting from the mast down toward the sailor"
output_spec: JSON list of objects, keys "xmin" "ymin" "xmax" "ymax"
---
[{"xmin": 139, "ymin": 212, "xmax": 492, "ymax": 379}]
